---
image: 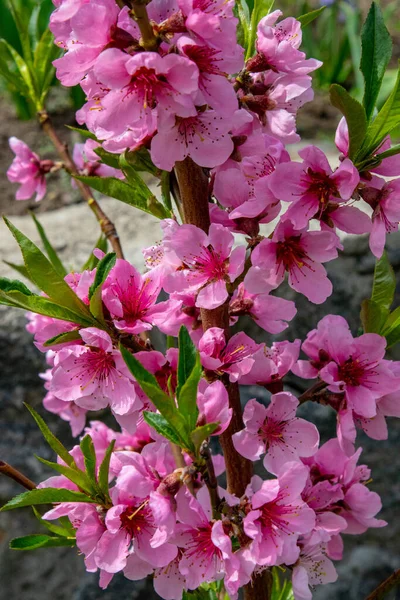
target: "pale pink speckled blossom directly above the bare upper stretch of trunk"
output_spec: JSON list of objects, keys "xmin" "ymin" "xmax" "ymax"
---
[{"xmin": 150, "ymin": 110, "xmax": 233, "ymax": 171}]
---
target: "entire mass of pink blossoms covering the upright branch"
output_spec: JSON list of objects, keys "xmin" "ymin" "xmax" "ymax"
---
[{"xmin": 4, "ymin": 0, "xmax": 400, "ymax": 600}]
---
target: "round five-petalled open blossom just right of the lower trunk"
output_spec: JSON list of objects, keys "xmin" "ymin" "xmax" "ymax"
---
[{"xmin": 232, "ymin": 392, "xmax": 319, "ymax": 475}]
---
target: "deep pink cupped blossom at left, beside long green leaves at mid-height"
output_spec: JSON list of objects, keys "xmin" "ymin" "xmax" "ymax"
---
[{"xmin": 102, "ymin": 259, "xmax": 168, "ymax": 334}]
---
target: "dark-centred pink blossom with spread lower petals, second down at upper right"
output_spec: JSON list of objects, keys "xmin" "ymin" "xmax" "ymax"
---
[{"xmin": 244, "ymin": 220, "xmax": 339, "ymax": 304}]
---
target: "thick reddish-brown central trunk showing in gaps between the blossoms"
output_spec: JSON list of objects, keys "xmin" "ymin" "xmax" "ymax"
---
[{"xmin": 175, "ymin": 158, "xmax": 271, "ymax": 600}]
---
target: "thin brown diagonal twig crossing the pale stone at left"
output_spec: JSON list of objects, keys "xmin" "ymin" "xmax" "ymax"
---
[{"xmin": 38, "ymin": 111, "xmax": 124, "ymax": 258}]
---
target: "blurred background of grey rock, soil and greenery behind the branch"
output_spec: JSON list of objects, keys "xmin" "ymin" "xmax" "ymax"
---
[{"xmin": 0, "ymin": 0, "xmax": 400, "ymax": 600}]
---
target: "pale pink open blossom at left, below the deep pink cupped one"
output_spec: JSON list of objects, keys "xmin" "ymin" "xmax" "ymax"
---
[{"xmin": 50, "ymin": 327, "xmax": 143, "ymax": 426}]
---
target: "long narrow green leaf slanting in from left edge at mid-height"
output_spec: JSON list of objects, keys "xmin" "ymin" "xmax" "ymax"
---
[{"xmin": 0, "ymin": 290, "xmax": 97, "ymax": 327}]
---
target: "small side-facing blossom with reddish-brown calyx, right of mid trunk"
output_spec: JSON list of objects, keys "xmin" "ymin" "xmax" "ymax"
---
[{"xmin": 229, "ymin": 283, "xmax": 297, "ymax": 333}]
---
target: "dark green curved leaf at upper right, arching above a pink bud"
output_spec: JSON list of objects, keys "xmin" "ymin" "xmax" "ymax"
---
[{"xmin": 329, "ymin": 84, "xmax": 367, "ymax": 159}]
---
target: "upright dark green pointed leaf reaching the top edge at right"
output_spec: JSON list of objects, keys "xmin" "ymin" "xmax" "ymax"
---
[{"xmin": 360, "ymin": 2, "xmax": 392, "ymax": 119}]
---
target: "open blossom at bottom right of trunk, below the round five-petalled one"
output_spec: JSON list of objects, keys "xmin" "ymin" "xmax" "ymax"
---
[{"xmin": 243, "ymin": 463, "xmax": 315, "ymax": 566}]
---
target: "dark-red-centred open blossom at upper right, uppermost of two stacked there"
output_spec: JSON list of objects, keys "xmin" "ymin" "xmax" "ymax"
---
[{"xmin": 268, "ymin": 146, "xmax": 371, "ymax": 233}]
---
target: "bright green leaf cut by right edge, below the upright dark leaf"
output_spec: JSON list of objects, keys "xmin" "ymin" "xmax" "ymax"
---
[{"xmin": 357, "ymin": 63, "xmax": 400, "ymax": 160}]
